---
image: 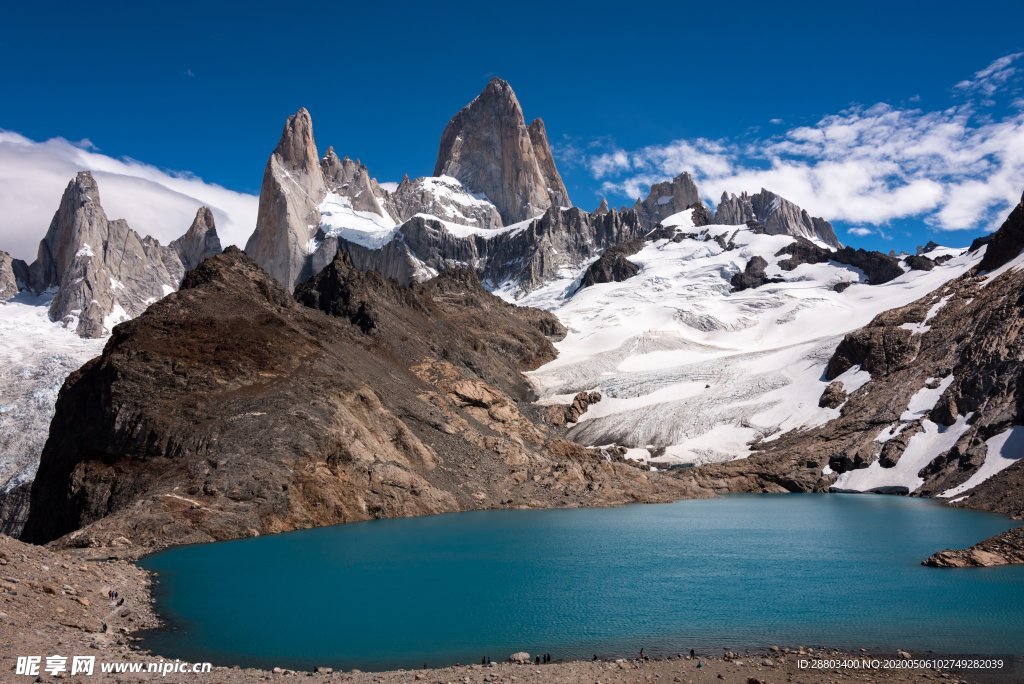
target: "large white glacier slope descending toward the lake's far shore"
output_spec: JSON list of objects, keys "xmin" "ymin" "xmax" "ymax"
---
[{"xmin": 518, "ymin": 212, "xmax": 978, "ymax": 463}]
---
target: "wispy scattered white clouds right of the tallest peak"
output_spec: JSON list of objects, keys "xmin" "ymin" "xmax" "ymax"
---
[{"xmin": 588, "ymin": 53, "xmax": 1024, "ymax": 234}]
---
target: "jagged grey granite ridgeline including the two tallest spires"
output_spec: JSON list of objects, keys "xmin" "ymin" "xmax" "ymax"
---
[{"xmin": 246, "ymin": 79, "xmax": 864, "ymax": 293}]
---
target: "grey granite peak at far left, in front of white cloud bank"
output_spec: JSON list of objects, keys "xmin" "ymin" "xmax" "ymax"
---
[{"xmin": 29, "ymin": 171, "xmax": 184, "ymax": 337}]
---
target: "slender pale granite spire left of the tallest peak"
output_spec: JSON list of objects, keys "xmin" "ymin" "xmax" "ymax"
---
[{"xmin": 246, "ymin": 109, "xmax": 328, "ymax": 289}]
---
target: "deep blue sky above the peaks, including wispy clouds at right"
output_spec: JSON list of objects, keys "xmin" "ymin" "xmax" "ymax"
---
[{"xmin": 0, "ymin": 0, "xmax": 1024, "ymax": 250}]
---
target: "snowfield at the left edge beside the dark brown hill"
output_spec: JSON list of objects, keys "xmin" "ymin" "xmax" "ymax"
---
[{"xmin": 0, "ymin": 293, "xmax": 106, "ymax": 493}]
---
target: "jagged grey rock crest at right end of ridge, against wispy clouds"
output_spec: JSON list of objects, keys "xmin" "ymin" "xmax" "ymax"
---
[{"xmin": 715, "ymin": 187, "xmax": 842, "ymax": 249}]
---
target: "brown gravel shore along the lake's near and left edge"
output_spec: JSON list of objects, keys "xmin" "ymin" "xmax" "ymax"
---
[{"xmin": 0, "ymin": 509, "xmax": 1021, "ymax": 684}]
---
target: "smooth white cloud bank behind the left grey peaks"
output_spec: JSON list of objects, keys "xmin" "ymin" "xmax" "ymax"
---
[{"xmin": 0, "ymin": 130, "xmax": 257, "ymax": 261}]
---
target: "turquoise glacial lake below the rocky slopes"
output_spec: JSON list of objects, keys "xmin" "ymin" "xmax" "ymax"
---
[{"xmin": 140, "ymin": 495, "xmax": 1024, "ymax": 671}]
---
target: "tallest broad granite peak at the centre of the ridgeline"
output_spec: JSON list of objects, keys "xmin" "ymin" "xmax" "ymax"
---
[{"xmin": 434, "ymin": 78, "xmax": 571, "ymax": 224}]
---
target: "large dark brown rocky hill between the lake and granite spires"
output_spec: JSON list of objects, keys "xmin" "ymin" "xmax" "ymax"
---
[{"xmin": 23, "ymin": 248, "xmax": 683, "ymax": 547}]
